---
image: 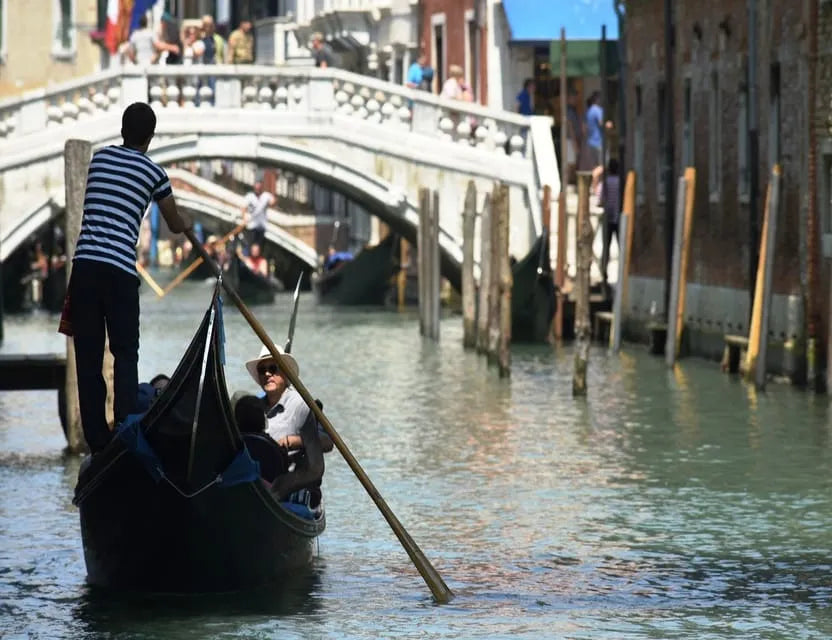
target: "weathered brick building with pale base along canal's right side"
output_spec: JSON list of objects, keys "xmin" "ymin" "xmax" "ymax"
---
[{"xmin": 625, "ymin": 0, "xmax": 828, "ymax": 381}]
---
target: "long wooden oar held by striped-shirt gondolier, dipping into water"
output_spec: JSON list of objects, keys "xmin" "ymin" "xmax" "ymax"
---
[{"xmin": 185, "ymin": 229, "xmax": 454, "ymax": 604}]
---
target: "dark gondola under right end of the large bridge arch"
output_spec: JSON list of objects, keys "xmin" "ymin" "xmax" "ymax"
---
[{"xmin": 312, "ymin": 233, "xmax": 395, "ymax": 306}]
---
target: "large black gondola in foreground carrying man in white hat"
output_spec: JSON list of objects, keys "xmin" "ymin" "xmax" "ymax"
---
[{"xmin": 74, "ymin": 282, "xmax": 325, "ymax": 593}]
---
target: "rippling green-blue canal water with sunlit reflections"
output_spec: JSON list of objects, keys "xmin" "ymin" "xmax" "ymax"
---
[{"xmin": 0, "ymin": 283, "xmax": 832, "ymax": 639}]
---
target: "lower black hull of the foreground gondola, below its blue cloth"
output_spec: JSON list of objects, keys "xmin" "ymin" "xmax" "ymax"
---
[{"xmin": 80, "ymin": 449, "xmax": 324, "ymax": 593}]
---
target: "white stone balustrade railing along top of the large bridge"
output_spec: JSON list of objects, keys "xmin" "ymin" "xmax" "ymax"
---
[{"xmin": 0, "ymin": 65, "xmax": 531, "ymax": 157}]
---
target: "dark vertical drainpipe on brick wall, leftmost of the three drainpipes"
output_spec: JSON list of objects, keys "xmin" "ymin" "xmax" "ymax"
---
[{"xmin": 664, "ymin": 0, "xmax": 676, "ymax": 319}]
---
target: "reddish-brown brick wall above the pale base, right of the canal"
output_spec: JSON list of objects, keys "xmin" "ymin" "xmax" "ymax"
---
[{"xmin": 626, "ymin": 0, "xmax": 808, "ymax": 294}]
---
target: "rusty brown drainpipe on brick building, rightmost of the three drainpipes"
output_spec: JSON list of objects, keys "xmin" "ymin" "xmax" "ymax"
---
[{"xmin": 806, "ymin": 0, "xmax": 821, "ymax": 388}]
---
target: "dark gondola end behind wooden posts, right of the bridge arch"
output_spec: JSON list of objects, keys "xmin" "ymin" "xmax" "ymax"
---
[{"xmin": 511, "ymin": 234, "xmax": 555, "ymax": 342}]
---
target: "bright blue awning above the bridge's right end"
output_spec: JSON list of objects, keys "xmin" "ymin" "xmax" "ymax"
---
[{"xmin": 503, "ymin": 0, "xmax": 618, "ymax": 43}]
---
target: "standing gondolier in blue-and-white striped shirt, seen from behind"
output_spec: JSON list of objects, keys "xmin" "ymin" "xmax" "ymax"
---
[{"xmin": 61, "ymin": 102, "xmax": 192, "ymax": 454}]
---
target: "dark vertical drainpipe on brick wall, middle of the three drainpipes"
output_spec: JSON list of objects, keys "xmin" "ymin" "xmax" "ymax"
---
[{"xmin": 747, "ymin": 0, "xmax": 760, "ymax": 326}]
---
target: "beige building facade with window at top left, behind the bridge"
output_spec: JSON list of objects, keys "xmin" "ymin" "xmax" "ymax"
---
[{"xmin": 0, "ymin": 0, "xmax": 101, "ymax": 98}]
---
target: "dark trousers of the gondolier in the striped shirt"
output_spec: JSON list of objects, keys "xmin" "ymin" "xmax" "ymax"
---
[{"xmin": 70, "ymin": 260, "xmax": 139, "ymax": 453}]
